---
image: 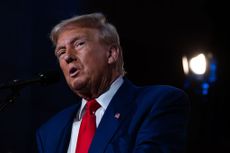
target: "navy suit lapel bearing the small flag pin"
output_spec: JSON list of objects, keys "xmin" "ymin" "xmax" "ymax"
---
[{"xmin": 89, "ymin": 79, "xmax": 136, "ymax": 153}]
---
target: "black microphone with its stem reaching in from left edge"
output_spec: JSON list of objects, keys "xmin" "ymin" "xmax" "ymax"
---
[{"xmin": 0, "ymin": 70, "xmax": 60, "ymax": 90}]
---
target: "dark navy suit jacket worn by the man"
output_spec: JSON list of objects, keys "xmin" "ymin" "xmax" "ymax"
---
[{"xmin": 37, "ymin": 79, "xmax": 189, "ymax": 153}]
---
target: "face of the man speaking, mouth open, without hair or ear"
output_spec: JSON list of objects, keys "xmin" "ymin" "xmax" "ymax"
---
[{"xmin": 55, "ymin": 28, "xmax": 111, "ymax": 97}]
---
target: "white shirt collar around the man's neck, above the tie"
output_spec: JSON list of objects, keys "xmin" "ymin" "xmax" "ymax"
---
[{"xmin": 77, "ymin": 76, "xmax": 124, "ymax": 120}]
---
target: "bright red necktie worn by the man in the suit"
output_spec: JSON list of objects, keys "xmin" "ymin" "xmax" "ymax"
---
[{"xmin": 76, "ymin": 99, "xmax": 101, "ymax": 153}]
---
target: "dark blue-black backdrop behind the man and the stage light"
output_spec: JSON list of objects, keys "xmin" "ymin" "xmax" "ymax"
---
[{"xmin": 0, "ymin": 0, "xmax": 230, "ymax": 153}]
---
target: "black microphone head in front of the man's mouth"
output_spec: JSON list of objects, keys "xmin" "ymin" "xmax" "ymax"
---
[{"xmin": 39, "ymin": 70, "xmax": 61, "ymax": 85}]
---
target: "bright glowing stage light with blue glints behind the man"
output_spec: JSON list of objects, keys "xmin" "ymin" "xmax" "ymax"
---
[{"xmin": 182, "ymin": 52, "xmax": 217, "ymax": 95}]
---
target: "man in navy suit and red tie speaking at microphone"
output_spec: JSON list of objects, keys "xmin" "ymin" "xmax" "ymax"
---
[{"xmin": 37, "ymin": 13, "xmax": 189, "ymax": 153}]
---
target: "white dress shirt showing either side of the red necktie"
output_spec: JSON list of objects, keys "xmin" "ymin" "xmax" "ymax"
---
[{"xmin": 67, "ymin": 76, "xmax": 124, "ymax": 153}]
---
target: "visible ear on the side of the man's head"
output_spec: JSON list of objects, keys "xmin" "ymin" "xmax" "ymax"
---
[{"xmin": 108, "ymin": 45, "xmax": 120, "ymax": 64}]
